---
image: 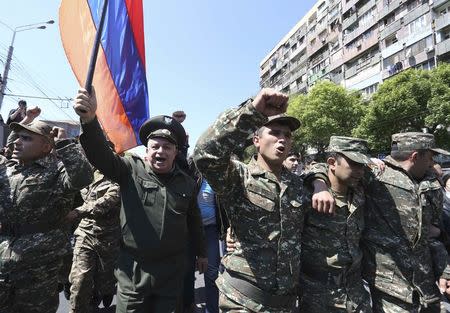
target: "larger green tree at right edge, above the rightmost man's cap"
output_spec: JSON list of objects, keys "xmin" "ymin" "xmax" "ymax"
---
[{"xmin": 353, "ymin": 64, "xmax": 450, "ymax": 152}]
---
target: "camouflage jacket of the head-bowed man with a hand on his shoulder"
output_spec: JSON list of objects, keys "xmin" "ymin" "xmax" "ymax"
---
[{"xmin": 301, "ymin": 188, "xmax": 365, "ymax": 283}]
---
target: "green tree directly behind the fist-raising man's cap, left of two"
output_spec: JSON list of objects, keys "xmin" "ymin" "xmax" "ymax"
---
[{"xmin": 288, "ymin": 80, "xmax": 364, "ymax": 152}]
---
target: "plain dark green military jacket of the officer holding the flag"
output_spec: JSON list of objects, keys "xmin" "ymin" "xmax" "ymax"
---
[{"xmin": 80, "ymin": 120, "xmax": 206, "ymax": 265}]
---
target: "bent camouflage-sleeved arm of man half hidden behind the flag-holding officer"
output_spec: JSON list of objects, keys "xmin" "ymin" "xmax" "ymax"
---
[{"xmin": 75, "ymin": 181, "xmax": 120, "ymax": 218}]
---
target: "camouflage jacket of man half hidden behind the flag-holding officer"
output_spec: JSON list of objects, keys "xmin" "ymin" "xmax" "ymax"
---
[{"xmin": 75, "ymin": 170, "xmax": 120, "ymax": 241}]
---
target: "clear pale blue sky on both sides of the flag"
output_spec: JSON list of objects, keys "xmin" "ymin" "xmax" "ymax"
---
[{"xmin": 0, "ymin": 0, "xmax": 316, "ymax": 151}]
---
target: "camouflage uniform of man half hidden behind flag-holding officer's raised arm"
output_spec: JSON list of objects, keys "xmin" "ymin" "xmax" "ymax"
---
[{"xmin": 70, "ymin": 171, "xmax": 120, "ymax": 313}]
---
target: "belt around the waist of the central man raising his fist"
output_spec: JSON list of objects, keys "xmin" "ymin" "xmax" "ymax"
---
[{"xmin": 222, "ymin": 271, "xmax": 297, "ymax": 308}]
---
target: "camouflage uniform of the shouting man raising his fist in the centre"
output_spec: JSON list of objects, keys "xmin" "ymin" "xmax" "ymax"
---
[{"xmin": 194, "ymin": 102, "xmax": 305, "ymax": 312}]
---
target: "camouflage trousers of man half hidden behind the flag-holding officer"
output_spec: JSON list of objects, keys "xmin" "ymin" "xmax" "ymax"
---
[{"xmin": 69, "ymin": 237, "xmax": 119, "ymax": 313}]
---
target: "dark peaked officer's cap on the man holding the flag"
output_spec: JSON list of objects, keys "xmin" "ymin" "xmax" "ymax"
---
[{"xmin": 139, "ymin": 115, "xmax": 186, "ymax": 147}]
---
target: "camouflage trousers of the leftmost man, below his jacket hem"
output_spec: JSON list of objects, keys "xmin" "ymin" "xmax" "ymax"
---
[{"xmin": 0, "ymin": 259, "xmax": 61, "ymax": 313}]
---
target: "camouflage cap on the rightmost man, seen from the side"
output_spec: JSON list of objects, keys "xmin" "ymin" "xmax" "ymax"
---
[{"xmin": 391, "ymin": 132, "xmax": 450, "ymax": 155}]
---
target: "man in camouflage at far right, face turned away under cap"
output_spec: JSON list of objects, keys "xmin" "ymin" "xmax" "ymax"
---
[{"xmin": 312, "ymin": 132, "xmax": 449, "ymax": 313}]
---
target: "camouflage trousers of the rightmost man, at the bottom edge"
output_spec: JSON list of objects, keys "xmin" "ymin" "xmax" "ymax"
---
[{"xmin": 371, "ymin": 289, "xmax": 441, "ymax": 313}]
